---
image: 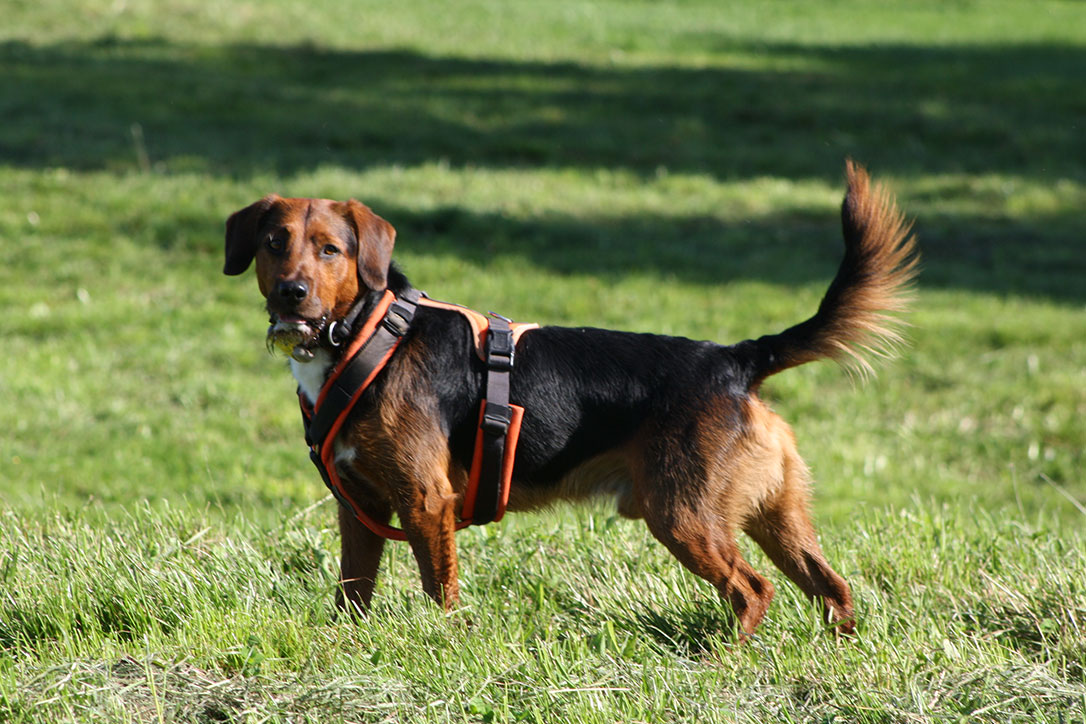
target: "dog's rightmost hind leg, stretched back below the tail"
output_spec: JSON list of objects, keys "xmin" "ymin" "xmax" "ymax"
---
[{"xmin": 743, "ymin": 450, "xmax": 856, "ymax": 634}]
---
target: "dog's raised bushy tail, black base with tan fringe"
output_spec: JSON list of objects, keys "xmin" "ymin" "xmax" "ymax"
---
[{"xmin": 740, "ymin": 161, "xmax": 919, "ymax": 389}]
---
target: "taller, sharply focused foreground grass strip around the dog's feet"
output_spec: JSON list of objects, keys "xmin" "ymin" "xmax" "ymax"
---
[{"xmin": 0, "ymin": 509, "xmax": 1086, "ymax": 722}]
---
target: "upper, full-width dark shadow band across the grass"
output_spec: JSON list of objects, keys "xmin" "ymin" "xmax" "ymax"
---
[{"xmin": 0, "ymin": 37, "xmax": 1086, "ymax": 178}]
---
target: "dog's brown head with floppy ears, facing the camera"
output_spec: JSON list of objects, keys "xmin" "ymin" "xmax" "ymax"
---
[{"xmin": 223, "ymin": 194, "xmax": 396, "ymax": 353}]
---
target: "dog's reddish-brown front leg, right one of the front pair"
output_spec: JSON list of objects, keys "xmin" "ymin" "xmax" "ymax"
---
[{"xmin": 400, "ymin": 477, "xmax": 459, "ymax": 611}]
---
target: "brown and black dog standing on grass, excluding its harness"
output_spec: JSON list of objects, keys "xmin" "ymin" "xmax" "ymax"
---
[{"xmin": 224, "ymin": 163, "xmax": 917, "ymax": 634}]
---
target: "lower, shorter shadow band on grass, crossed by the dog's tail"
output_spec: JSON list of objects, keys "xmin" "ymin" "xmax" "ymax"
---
[{"xmin": 368, "ymin": 199, "xmax": 1086, "ymax": 303}]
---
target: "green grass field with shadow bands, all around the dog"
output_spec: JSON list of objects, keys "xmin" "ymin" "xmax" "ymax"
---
[{"xmin": 0, "ymin": 0, "xmax": 1086, "ymax": 723}]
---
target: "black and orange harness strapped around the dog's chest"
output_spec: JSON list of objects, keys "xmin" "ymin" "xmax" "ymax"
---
[{"xmin": 298, "ymin": 291, "xmax": 539, "ymax": 541}]
